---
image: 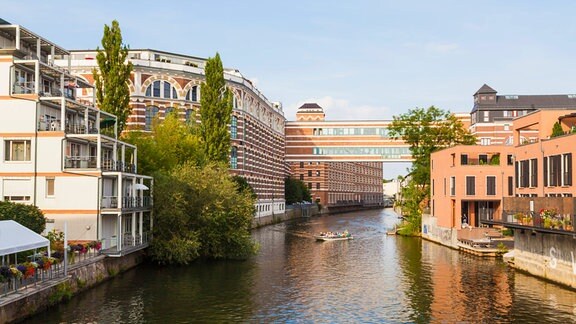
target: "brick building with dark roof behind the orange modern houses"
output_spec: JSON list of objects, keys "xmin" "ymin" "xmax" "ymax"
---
[{"xmin": 470, "ymin": 84, "xmax": 576, "ymax": 145}]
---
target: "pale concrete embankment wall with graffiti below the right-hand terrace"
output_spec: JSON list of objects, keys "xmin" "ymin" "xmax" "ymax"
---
[{"xmin": 513, "ymin": 230, "xmax": 576, "ymax": 288}]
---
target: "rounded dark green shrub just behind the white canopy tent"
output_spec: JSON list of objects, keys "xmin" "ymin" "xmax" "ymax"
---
[{"xmin": 0, "ymin": 201, "xmax": 46, "ymax": 234}]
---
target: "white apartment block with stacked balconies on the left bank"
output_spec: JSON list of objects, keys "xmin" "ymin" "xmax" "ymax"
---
[{"xmin": 0, "ymin": 21, "xmax": 152, "ymax": 255}]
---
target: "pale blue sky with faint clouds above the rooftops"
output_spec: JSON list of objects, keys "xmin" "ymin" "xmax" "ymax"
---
[{"xmin": 0, "ymin": 0, "xmax": 576, "ymax": 177}]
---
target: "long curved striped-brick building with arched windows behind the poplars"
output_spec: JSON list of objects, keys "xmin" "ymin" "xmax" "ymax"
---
[{"xmin": 57, "ymin": 49, "xmax": 286, "ymax": 216}]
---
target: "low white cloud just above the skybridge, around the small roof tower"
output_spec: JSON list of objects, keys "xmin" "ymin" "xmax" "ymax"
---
[{"xmin": 284, "ymin": 96, "xmax": 392, "ymax": 120}]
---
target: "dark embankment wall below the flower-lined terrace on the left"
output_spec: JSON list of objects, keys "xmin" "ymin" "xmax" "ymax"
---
[{"xmin": 0, "ymin": 251, "xmax": 145, "ymax": 323}]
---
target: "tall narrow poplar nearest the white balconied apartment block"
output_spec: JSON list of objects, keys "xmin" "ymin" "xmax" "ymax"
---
[{"xmin": 92, "ymin": 20, "xmax": 133, "ymax": 133}]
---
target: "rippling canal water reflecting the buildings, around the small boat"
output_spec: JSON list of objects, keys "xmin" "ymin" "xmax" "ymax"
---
[{"xmin": 29, "ymin": 209, "xmax": 576, "ymax": 323}]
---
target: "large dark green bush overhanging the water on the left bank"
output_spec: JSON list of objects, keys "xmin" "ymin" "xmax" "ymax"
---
[{"xmin": 151, "ymin": 163, "xmax": 257, "ymax": 264}]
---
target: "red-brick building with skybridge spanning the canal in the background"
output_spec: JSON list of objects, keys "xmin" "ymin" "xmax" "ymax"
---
[{"xmin": 286, "ymin": 103, "xmax": 384, "ymax": 208}]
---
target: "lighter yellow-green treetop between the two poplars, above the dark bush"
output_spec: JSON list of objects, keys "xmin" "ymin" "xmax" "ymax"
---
[{"xmin": 125, "ymin": 114, "xmax": 205, "ymax": 175}]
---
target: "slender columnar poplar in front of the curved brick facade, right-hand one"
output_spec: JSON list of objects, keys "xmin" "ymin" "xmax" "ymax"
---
[{"xmin": 200, "ymin": 53, "xmax": 232, "ymax": 163}]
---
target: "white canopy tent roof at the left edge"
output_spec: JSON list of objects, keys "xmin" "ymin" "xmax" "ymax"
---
[{"xmin": 0, "ymin": 220, "xmax": 50, "ymax": 256}]
